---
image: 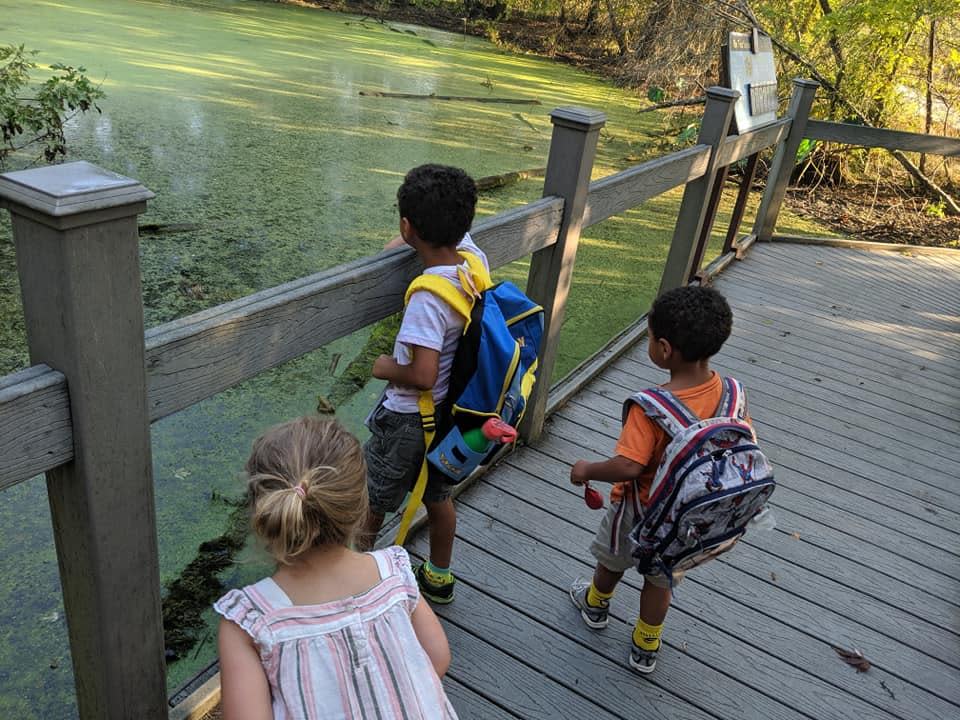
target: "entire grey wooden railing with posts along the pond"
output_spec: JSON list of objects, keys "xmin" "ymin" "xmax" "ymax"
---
[{"xmin": 0, "ymin": 80, "xmax": 960, "ymax": 719}]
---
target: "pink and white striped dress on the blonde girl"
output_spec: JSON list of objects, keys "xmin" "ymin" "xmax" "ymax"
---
[{"xmin": 213, "ymin": 547, "xmax": 457, "ymax": 720}]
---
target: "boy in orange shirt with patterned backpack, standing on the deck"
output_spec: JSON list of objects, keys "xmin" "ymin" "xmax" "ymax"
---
[{"xmin": 570, "ymin": 286, "xmax": 774, "ymax": 673}]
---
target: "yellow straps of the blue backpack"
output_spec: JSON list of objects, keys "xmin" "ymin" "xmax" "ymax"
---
[{"xmin": 394, "ymin": 251, "xmax": 493, "ymax": 545}]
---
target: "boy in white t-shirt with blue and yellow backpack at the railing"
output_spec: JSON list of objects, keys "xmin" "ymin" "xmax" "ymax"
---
[{"xmin": 364, "ymin": 165, "xmax": 543, "ymax": 604}]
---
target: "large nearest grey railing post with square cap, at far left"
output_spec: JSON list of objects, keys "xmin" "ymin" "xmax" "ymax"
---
[{"xmin": 0, "ymin": 162, "xmax": 168, "ymax": 720}]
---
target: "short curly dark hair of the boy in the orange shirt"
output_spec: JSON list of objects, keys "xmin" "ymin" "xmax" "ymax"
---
[{"xmin": 647, "ymin": 285, "xmax": 733, "ymax": 362}]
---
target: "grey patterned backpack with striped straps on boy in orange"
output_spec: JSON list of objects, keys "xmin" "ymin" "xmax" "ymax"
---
[{"xmin": 623, "ymin": 378, "xmax": 775, "ymax": 577}]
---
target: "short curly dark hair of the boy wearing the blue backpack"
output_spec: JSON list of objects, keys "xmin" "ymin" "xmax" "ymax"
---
[{"xmin": 397, "ymin": 165, "xmax": 477, "ymax": 247}]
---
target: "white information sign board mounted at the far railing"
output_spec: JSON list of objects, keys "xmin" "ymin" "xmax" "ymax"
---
[{"xmin": 724, "ymin": 29, "xmax": 777, "ymax": 133}]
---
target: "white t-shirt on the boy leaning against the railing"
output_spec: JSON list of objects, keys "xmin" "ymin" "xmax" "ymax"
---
[{"xmin": 383, "ymin": 233, "xmax": 490, "ymax": 413}]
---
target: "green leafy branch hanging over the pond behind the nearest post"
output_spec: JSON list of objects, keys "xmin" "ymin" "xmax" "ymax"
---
[{"xmin": 0, "ymin": 45, "xmax": 104, "ymax": 167}]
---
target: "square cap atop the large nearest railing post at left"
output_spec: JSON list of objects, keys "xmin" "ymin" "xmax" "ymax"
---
[{"xmin": 0, "ymin": 160, "xmax": 154, "ymax": 227}]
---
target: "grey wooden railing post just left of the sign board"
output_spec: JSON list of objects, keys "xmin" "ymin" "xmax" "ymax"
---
[{"xmin": 658, "ymin": 86, "xmax": 740, "ymax": 294}]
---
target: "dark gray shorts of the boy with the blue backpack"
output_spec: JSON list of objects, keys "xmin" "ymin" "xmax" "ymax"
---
[{"xmin": 363, "ymin": 404, "xmax": 453, "ymax": 514}]
